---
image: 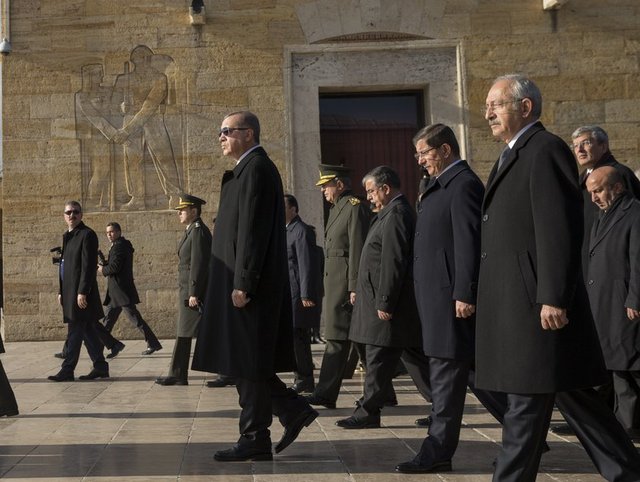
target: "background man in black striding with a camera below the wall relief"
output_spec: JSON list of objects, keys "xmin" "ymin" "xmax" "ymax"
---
[{"xmin": 98, "ymin": 222, "xmax": 162, "ymax": 358}]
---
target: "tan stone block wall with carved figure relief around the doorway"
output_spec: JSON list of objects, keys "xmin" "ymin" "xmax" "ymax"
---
[{"xmin": 1, "ymin": 0, "xmax": 640, "ymax": 340}]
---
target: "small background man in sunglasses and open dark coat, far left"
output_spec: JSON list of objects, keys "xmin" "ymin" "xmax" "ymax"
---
[{"xmin": 48, "ymin": 201, "xmax": 109, "ymax": 382}]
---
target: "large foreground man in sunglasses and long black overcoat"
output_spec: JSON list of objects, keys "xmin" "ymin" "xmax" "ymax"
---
[{"xmin": 193, "ymin": 111, "xmax": 318, "ymax": 461}]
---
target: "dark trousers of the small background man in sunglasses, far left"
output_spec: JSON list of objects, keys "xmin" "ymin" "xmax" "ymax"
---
[{"xmin": 60, "ymin": 321, "xmax": 109, "ymax": 374}]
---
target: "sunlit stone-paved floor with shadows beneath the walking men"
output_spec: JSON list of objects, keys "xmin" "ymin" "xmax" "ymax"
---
[{"xmin": 0, "ymin": 340, "xmax": 620, "ymax": 482}]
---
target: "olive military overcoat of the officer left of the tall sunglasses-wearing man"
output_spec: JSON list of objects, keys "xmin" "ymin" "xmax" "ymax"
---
[{"xmin": 178, "ymin": 218, "xmax": 211, "ymax": 337}]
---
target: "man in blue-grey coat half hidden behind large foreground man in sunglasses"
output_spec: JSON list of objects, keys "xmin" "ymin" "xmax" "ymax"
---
[{"xmin": 284, "ymin": 194, "xmax": 322, "ymax": 393}]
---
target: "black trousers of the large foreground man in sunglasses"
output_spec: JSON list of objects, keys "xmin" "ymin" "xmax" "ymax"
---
[{"xmin": 236, "ymin": 375, "xmax": 311, "ymax": 444}]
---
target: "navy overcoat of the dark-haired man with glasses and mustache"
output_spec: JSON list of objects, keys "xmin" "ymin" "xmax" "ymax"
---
[{"xmin": 413, "ymin": 161, "xmax": 484, "ymax": 360}]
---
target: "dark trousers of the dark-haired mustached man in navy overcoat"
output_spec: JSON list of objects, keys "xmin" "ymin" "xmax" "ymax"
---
[{"xmin": 417, "ymin": 357, "xmax": 506, "ymax": 465}]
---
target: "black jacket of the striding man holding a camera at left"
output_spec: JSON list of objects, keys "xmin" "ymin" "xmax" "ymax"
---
[{"xmin": 102, "ymin": 236, "xmax": 140, "ymax": 307}]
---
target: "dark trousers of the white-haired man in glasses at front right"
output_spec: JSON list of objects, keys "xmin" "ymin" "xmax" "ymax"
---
[{"xmin": 493, "ymin": 388, "xmax": 640, "ymax": 482}]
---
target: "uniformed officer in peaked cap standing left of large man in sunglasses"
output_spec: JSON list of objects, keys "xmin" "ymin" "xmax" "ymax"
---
[{"xmin": 156, "ymin": 194, "xmax": 211, "ymax": 385}]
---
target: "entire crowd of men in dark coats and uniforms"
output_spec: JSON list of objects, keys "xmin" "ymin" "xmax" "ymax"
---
[{"xmin": 0, "ymin": 75, "xmax": 640, "ymax": 482}]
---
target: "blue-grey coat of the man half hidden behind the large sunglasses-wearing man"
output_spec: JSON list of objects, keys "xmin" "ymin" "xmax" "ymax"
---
[{"xmin": 287, "ymin": 216, "xmax": 322, "ymax": 328}]
